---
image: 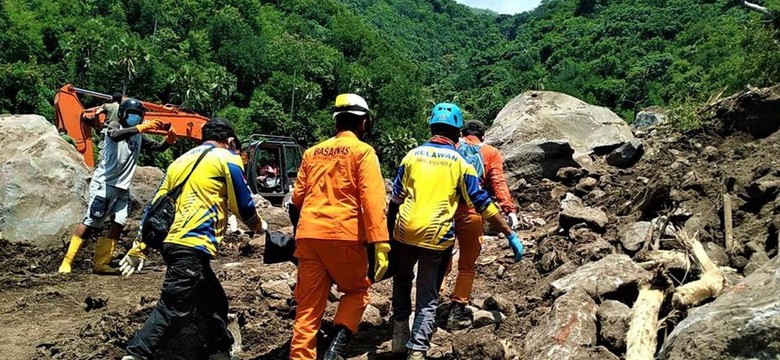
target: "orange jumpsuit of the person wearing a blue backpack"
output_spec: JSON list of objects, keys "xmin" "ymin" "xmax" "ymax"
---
[{"xmin": 451, "ymin": 135, "xmax": 517, "ymax": 304}]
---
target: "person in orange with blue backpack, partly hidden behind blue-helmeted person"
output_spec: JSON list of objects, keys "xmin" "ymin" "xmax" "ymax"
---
[{"xmin": 447, "ymin": 120, "xmax": 519, "ymax": 330}]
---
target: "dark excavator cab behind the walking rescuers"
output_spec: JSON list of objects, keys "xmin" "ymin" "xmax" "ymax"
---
[{"xmin": 242, "ymin": 134, "xmax": 303, "ymax": 206}]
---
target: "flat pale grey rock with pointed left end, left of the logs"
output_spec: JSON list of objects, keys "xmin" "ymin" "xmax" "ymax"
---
[{"xmin": 550, "ymin": 254, "xmax": 651, "ymax": 299}]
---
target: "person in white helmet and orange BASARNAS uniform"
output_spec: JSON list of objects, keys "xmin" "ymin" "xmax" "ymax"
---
[{"xmin": 290, "ymin": 94, "xmax": 390, "ymax": 360}]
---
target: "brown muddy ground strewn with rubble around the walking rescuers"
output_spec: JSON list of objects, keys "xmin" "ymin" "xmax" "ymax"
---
[{"xmin": 0, "ymin": 93, "xmax": 780, "ymax": 359}]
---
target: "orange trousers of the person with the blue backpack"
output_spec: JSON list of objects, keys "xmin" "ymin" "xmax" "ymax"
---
[{"xmin": 450, "ymin": 211, "xmax": 484, "ymax": 304}]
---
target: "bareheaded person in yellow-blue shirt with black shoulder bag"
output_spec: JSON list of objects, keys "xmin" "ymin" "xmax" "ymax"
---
[{"xmin": 122, "ymin": 118, "xmax": 268, "ymax": 360}]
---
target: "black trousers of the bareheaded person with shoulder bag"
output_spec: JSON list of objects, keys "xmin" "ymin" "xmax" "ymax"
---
[{"xmin": 127, "ymin": 244, "xmax": 233, "ymax": 360}]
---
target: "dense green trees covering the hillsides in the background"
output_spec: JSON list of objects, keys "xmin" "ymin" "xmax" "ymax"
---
[{"xmin": 0, "ymin": 0, "xmax": 780, "ymax": 172}]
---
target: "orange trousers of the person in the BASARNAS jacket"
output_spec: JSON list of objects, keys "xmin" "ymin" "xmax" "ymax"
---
[{"xmin": 290, "ymin": 239, "xmax": 371, "ymax": 360}]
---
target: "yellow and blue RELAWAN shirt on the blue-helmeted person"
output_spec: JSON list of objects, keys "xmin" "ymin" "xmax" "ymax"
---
[{"xmin": 392, "ymin": 136, "xmax": 499, "ymax": 250}]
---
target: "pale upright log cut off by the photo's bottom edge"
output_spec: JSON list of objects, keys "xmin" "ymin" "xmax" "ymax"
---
[{"xmin": 626, "ymin": 281, "xmax": 665, "ymax": 360}]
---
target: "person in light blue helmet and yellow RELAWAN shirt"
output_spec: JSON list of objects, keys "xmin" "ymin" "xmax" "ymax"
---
[{"xmin": 388, "ymin": 103, "xmax": 522, "ymax": 360}]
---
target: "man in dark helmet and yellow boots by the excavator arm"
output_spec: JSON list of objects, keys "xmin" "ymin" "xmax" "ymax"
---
[{"xmin": 58, "ymin": 99, "xmax": 176, "ymax": 274}]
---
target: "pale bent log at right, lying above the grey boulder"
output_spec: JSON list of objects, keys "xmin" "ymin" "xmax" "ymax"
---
[{"xmin": 672, "ymin": 231, "xmax": 725, "ymax": 307}]
